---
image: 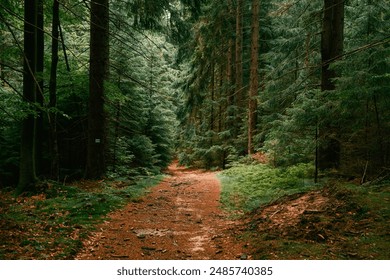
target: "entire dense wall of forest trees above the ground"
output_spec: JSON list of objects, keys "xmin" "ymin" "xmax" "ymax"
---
[{"xmin": 0, "ymin": 0, "xmax": 390, "ymax": 193}]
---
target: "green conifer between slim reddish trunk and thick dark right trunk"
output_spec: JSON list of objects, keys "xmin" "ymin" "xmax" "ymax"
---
[{"xmin": 256, "ymin": 1, "xmax": 327, "ymax": 168}]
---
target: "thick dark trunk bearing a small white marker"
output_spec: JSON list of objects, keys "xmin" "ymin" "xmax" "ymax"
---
[{"xmin": 85, "ymin": 0, "xmax": 109, "ymax": 179}]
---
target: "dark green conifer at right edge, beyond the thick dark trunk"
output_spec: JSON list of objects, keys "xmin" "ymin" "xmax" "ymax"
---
[{"xmin": 332, "ymin": 0, "xmax": 390, "ymax": 178}]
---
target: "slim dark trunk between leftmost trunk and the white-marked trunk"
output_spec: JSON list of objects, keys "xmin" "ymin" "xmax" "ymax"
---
[{"xmin": 49, "ymin": 0, "xmax": 60, "ymax": 180}]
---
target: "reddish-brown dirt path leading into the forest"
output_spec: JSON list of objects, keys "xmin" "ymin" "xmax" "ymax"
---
[{"xmin": 76, "ymin": 164, "xmax": 246, "ymax": 260}]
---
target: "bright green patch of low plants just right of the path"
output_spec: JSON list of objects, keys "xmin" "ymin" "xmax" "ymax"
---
[{"xmin": 219, "ymin": 164, "xmax": 314, "ymax": 212}]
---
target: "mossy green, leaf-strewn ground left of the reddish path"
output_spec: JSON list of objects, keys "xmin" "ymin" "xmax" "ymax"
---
[{"xmin": 0, "ymin": 176, "xmax": 162, "ymax": 259}]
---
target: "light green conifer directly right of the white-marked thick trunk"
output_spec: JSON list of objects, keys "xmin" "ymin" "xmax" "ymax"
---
[{"xmin": 108, "ymin": 0, "xmax": 177, "ymax": 176}]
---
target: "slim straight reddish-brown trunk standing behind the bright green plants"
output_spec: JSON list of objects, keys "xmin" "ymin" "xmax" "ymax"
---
[{"xmin": 248, "ymin": 0, "xmax": 260, "ymax": 155}]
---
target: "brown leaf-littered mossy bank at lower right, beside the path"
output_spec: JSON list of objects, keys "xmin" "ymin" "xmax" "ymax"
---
[{"xmin": 248, "ymin": 181, "xmax": 390, "ymax": 260}]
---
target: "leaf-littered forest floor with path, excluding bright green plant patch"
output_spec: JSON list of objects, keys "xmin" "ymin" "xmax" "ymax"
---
[{"xmin": 0, "ymin": 164, "xmax": 390, "ymax": 260}]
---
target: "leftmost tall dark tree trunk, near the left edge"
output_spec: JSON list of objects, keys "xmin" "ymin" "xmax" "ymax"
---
[{"xmin": 16, "ymin": 0, "xmax": 38, "ymax": 194}]
